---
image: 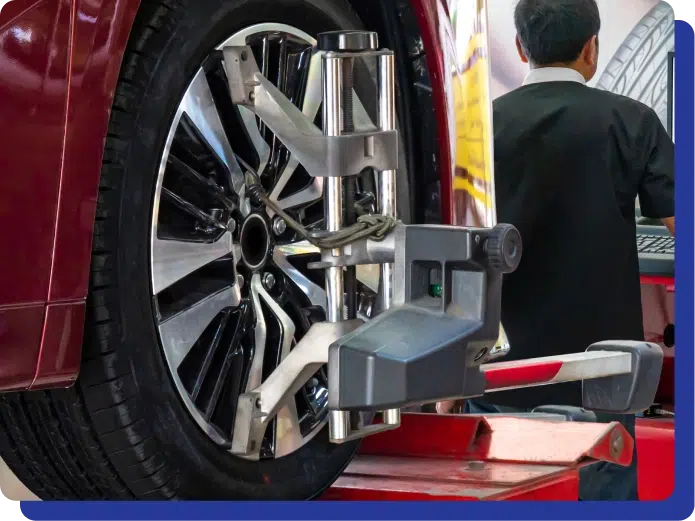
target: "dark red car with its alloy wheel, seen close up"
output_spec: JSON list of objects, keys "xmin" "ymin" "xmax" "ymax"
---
[{"xmin": 0, "ymin": 0, "xmax": 474, "ymax": 499}]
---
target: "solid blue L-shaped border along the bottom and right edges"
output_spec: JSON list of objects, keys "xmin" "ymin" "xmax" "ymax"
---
[{"xmin": 20, "ymin": 14, "xmax": 695, "ymax": 521}]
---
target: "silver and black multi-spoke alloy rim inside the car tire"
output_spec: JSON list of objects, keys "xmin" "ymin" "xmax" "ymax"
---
[{"xmin": 150, "ymin": 23, "xmax": 373, "ymax": 458}]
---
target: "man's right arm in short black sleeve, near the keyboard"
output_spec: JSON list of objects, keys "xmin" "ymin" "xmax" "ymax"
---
[{"xmin": 638, "ymin": 109, "xmax": 676, "ymax": 236}]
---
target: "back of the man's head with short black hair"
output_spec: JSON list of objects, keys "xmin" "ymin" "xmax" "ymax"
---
[{"xmin": 514, "ymin": 0, "xmax": 601, "ymax": 81}]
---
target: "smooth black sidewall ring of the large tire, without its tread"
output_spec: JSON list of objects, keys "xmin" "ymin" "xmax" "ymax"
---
[{"xmin": 109, "ymin": 0, "xmax": 370, "ymax": 499}]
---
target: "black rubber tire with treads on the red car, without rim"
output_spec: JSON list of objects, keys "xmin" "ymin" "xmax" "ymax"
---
[{"xmin": 0, "ymin": 0, "xmax": 408, "ymax": 500}]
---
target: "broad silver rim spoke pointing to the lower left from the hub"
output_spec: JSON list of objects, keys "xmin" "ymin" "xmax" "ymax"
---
[{"xmin": 159, "ymin": 286, "xmax": 240, "ymax": 369}]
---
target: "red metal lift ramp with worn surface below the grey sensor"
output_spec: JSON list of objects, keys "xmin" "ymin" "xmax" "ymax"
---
[{"xmin": 322, "ymin": 413, "xmax": 634, "ymax": 501}]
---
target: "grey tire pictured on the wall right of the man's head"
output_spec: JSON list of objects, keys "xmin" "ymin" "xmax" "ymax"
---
[{"xmin": 596, "ymin": 1, "xmax": 675, "ymax": 127}]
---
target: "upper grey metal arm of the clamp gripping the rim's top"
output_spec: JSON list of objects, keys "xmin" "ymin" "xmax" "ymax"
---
[{"xmin": 223, "ymin": 46, "xmax": 398, "ymax": 177}]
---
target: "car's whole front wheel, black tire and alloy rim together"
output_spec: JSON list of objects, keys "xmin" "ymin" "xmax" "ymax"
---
[{"xmin": 0, "ymin": 0, "xmax": 409, "ymax": 499}]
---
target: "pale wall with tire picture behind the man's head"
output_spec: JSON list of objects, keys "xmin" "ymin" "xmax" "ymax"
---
[{"xmin": 488, "ymin": 0, "xmax": 675, "ymax": 125}]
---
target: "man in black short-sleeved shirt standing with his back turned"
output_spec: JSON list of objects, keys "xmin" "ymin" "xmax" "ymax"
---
[{"xmin": 438, "ymin": 0, "xmax": 675, "ymax": 501}]
